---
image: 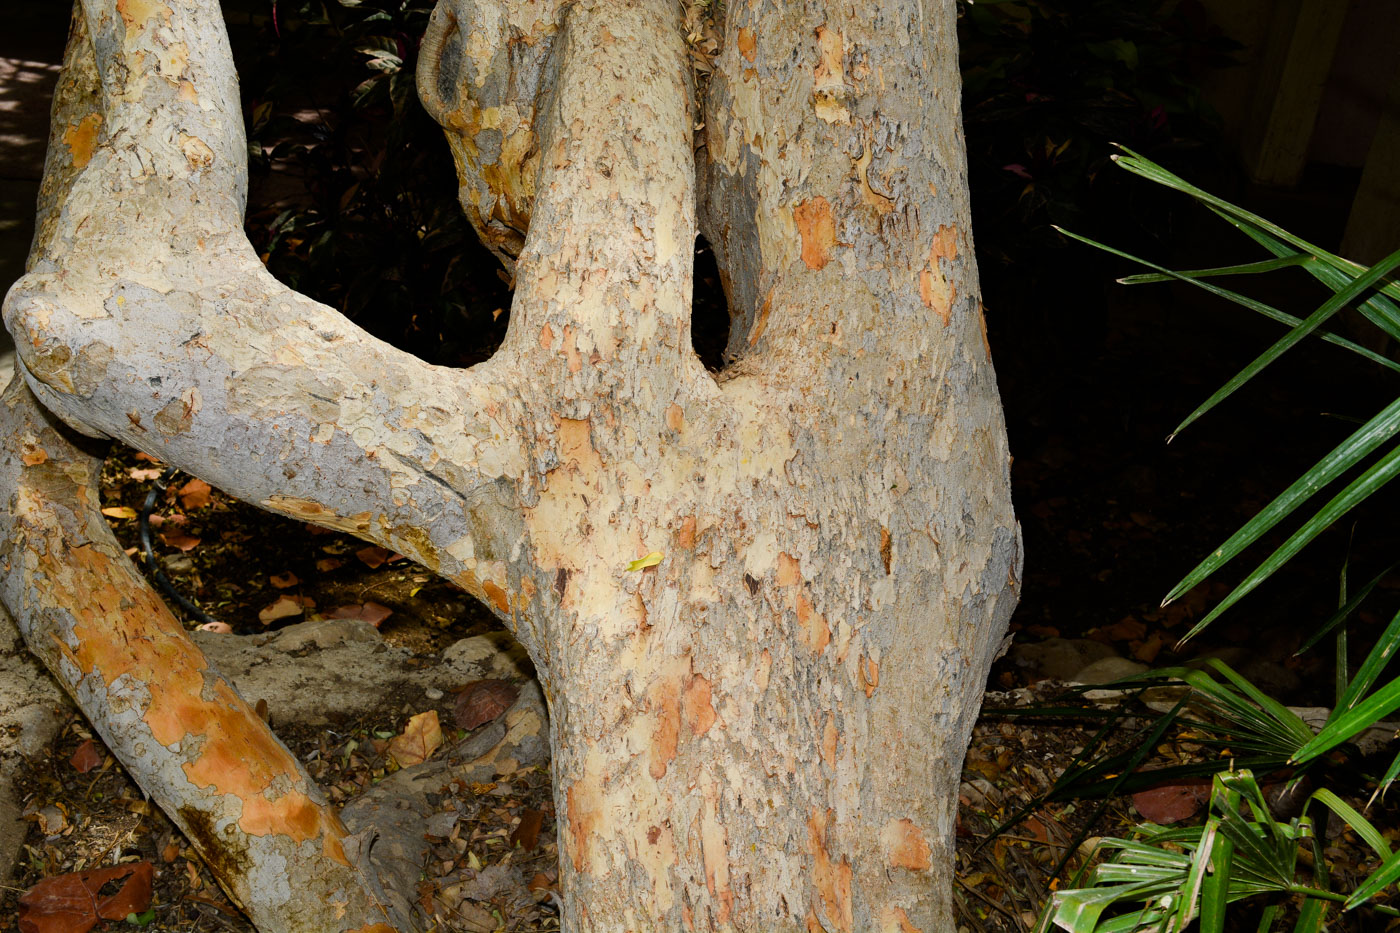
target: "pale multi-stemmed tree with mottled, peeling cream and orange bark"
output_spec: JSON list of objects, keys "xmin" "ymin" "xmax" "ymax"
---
[{"xmin": 0, "ymin": 0, "xmax": 1021, "ymax": 933}]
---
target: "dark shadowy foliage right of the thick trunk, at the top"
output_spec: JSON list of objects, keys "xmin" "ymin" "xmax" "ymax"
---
[{"xmin": 959, "ymin": 0, "xmax": 1235, "ymax": 273}]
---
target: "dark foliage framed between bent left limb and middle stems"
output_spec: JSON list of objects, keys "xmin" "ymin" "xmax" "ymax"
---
[{"xmin": 235, "ymin": 0, "xmax": 510, "ymax": 366}]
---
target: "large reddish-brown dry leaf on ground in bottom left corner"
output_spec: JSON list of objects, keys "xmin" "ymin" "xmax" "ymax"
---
[{"xmin": 20, "ymin": 862, "xmax": 154, "ymax": 933}]
